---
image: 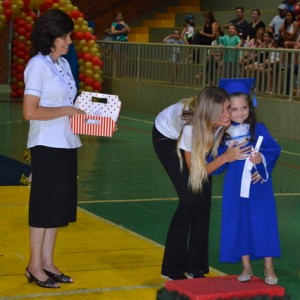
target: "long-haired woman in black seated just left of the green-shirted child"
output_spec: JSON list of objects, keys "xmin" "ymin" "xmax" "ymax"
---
[{"xmin": 193, "ymin": 10, "xmax": 220, "ymax": 45}]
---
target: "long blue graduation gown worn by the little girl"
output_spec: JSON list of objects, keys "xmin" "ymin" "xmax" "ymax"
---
[{"xmin": 220, "ymin": 123, "xmax": 281, "ymax": 263}]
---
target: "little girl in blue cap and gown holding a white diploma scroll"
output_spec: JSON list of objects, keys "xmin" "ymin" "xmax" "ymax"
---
[{"xmin": 219, "ymin": 79, "xmax": 281, "ymax": 285}]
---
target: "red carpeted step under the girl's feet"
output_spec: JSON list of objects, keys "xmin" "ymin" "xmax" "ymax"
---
[{"xmin": 165, "ymin": 275, "xmax": 285, "ymax": 300}]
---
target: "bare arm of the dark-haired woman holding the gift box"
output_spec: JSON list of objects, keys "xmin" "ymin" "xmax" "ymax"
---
[{"xmin": 23, "ymin": 95, "xmax": 85, "ymax": 121}]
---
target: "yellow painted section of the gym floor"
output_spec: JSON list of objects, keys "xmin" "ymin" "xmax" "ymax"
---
[{"xmin": 0, "ymin": 186, "xmax": 225, "ymax": 300}]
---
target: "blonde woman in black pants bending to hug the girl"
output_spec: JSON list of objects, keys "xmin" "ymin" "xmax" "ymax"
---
[{"xmin": 152, "ymin": 87, "xmax": 249, "ymax": 280}]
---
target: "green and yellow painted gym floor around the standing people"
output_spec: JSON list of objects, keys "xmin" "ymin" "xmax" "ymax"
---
[{"xmin": 0, "ymin": 95, "xmax": 300, "ymax": 300}]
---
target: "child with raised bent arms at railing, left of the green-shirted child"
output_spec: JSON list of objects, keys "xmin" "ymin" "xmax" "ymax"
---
[{"xmin": 163, "ymin": 29, "xmax": 188, "ymax": 84}]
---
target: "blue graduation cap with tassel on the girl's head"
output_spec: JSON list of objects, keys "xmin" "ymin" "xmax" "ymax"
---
[{"xmin": 218, "ymin": 78, "xmax": 257, "ymax": 106}]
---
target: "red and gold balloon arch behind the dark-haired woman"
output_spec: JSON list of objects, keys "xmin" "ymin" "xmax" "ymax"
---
[{"xmin": 0, "ymin": 0, "xmax": 103, "ymax": 98}]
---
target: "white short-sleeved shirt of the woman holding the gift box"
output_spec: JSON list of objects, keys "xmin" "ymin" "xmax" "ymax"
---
[{"xmin": 24, "ymin": 54, "xmax": 82, "ymax": 149}]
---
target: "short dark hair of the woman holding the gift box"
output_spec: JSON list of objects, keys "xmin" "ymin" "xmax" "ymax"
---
[{"xmin": 30, "ymin": 9, "xmax": 74, "ymax": 56}]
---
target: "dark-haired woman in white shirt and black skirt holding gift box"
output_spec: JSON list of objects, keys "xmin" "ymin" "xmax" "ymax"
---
[{"xmin": 23, "ymin": 9, "xmax": 84, "ymax": 288}]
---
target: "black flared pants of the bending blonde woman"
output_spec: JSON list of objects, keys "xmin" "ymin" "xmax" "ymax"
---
[{"xmin": 152, "ymin": 126, "xmax": 211, "ymax": 277}]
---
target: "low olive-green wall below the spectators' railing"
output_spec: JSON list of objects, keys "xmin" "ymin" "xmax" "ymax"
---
[{"xmin": 102, "ymin": 77, "xmax": 300, "ymax": 141}]
